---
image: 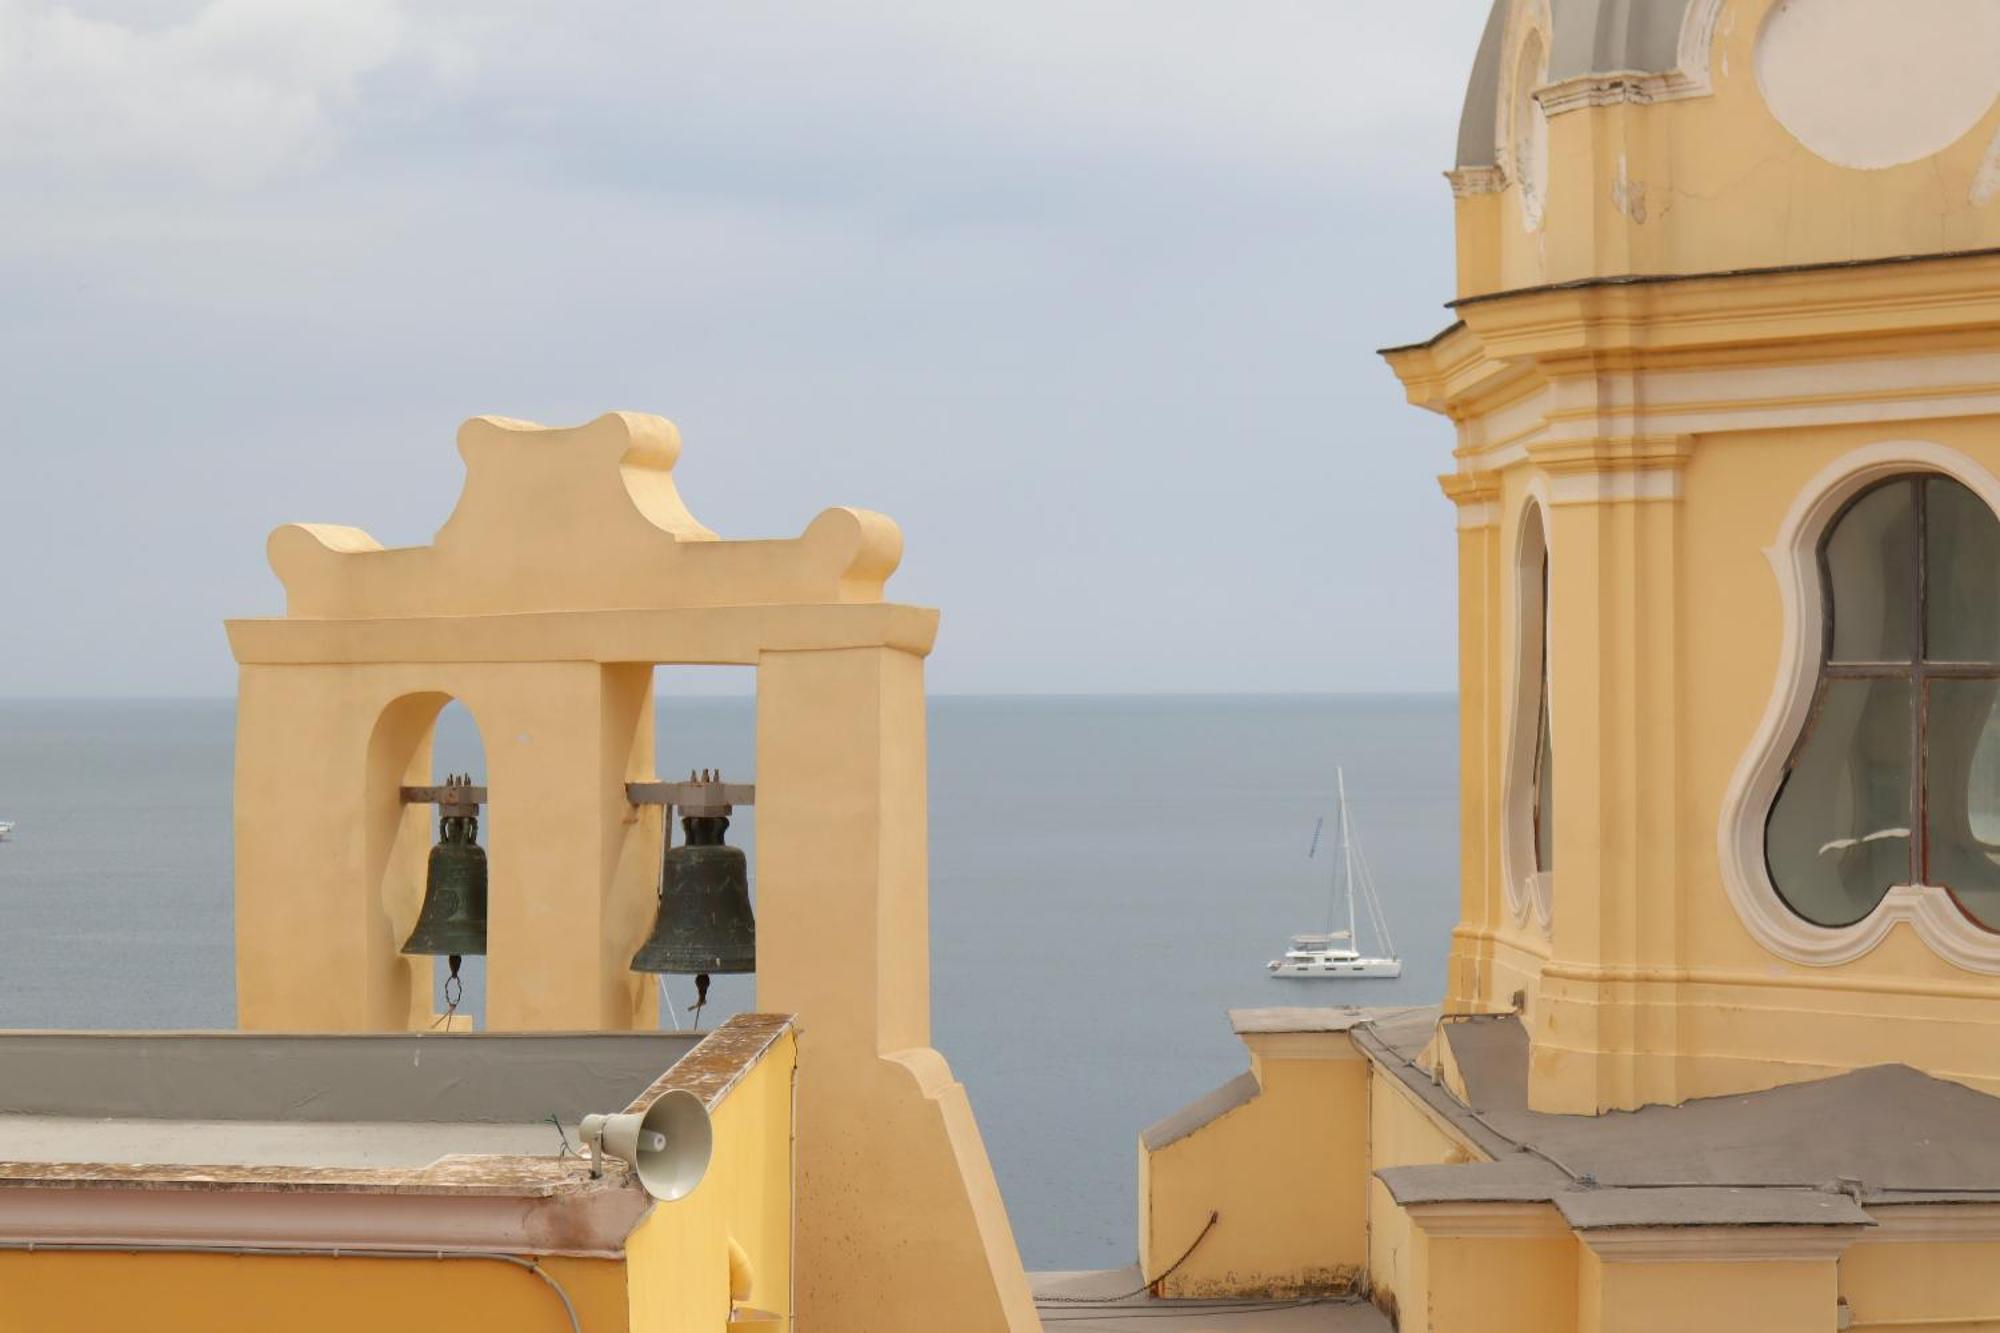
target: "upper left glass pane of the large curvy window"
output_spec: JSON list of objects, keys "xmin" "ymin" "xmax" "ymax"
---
[{"xmin": 1826, "ymin": 480, "xmax": 1916, "ymax": 662}]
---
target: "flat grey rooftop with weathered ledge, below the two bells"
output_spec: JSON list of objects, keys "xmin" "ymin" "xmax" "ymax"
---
[{"xmin": 0, "ymin": 1015, "xmax": 790, "ymax": 1257}]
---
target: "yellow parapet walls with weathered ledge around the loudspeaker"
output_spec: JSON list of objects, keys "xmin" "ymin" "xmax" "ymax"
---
[{"xmin": 0, "ymin": 1015, "xmax": 792, "ymax": 1333}]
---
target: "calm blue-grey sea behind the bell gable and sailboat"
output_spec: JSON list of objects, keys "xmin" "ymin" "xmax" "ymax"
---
[{"xmin": 0, "ymin": 697, "xmax": 1458, "ymax": 1269}]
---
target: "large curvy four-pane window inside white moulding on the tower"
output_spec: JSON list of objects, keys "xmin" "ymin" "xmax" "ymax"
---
[{"xmin": 1764, "ymin": 472, "xmax": 2000, "ymax": 931}]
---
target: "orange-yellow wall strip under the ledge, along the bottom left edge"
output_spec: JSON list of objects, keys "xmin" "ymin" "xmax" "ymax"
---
[{"xmin": 0, "ymin": 1251, "xmax": 628, "ymax": 1333}]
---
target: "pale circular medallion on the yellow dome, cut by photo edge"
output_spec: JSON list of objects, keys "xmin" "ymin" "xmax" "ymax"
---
[{"xmin": 1756, "ymin": 0, "xmax": 2000, "ymax": 168}]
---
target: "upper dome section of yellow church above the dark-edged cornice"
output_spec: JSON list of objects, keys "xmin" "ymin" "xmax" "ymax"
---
[{"xmin": 1448, "ymin": 0, "xmax": 2000, "ymax": 296}]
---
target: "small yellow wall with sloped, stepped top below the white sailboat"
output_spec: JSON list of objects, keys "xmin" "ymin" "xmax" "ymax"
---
[{"xmin": 1140, "ymin": 1033, "xmax": 1368, "ymax": 1297}]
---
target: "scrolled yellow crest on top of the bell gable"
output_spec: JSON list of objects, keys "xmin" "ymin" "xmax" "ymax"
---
[{"xmin": 268, "ymin": 412, "xmax": 902, "ymax": 620}]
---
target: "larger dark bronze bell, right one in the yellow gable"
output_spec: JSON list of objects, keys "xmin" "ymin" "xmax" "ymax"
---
[{"xmin": 632, "ymin": 815, "xmax": 756, "ymax": 972}]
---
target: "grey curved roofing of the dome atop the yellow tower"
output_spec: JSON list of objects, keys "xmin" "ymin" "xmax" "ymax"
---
[{"xmin": 1458, "ymin": 0, "xmax": 1712, "ymax": 166}]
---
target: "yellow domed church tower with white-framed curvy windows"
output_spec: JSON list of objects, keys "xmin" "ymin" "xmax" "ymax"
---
[{"xmin": 1386, "ymin": 0, "xmax": 2000, "ymax": 1113}]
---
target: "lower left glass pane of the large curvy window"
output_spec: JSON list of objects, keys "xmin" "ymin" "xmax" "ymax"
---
[{"xmin": 1764, "ymin": 681, "xmax": 1916, "ymax": 927}]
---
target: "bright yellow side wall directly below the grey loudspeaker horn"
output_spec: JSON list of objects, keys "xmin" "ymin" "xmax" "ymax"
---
[{"xmin": 626, "ymin": 1031, "xmax": 798, "ymax": 1333}]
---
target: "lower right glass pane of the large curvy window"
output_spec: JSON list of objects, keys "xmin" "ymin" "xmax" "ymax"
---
[{"xmin": 1924, "ymin": 681, "xmax": 2000, "ymax": 929}]
